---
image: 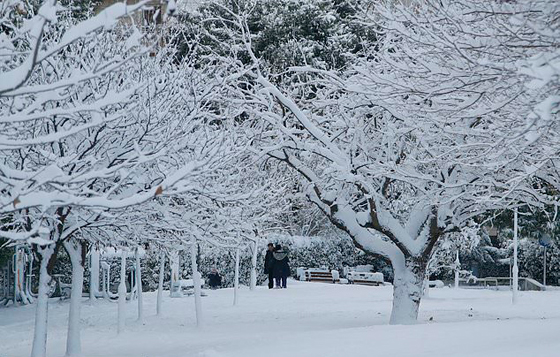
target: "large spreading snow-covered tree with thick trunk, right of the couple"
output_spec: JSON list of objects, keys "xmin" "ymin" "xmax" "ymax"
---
[{"xmin": 195, "ymin": 1, "xmax": 558, "ymax": 323}]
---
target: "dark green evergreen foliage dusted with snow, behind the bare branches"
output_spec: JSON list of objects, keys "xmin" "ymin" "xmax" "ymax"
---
[{"xmin": 186, "ymin": 0, "xmax": 375, "ymax": 72}]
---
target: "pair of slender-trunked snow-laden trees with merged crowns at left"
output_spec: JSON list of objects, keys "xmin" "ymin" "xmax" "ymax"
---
[{"xmin": 0, "ymin": 0, "xmax": 280, "ymax": 356}]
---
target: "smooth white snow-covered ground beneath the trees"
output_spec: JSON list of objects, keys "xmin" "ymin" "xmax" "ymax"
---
[{"xmin": 0, "ymin": 281, "xmax": 560, "ymax": 357}]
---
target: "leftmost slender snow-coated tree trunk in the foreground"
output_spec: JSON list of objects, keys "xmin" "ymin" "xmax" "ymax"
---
[{"xmin": 31, "ymin": 245, "xmax": 54, "ymax": 357}]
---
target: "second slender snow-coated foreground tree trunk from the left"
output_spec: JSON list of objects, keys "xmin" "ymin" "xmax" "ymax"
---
[{"xmin": 64, "ymin": 241, "xmax": 84, "ymax": 356}]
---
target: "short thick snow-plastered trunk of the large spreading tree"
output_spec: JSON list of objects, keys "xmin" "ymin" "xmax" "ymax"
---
[{"xmin": 389, "ymin": 258, "xmax": 426, "ymax": 325}]
